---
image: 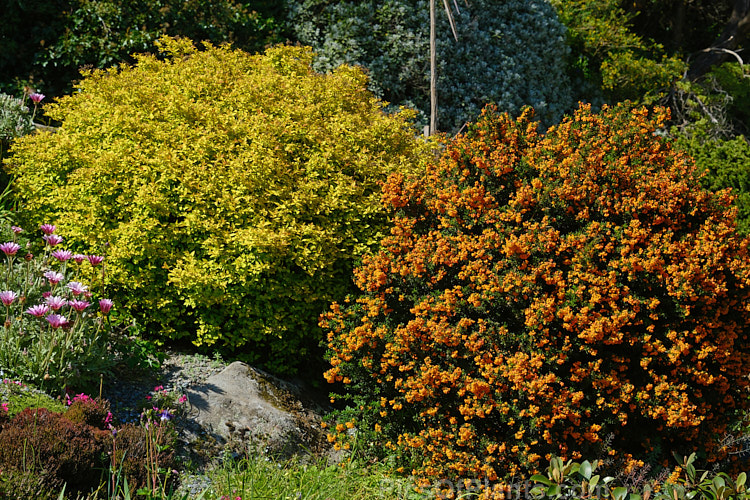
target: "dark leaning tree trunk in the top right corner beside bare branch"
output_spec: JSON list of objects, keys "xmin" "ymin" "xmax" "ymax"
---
[{"xmin": 687, "ymin": 0, "xmax": 750, "ymax": 81}]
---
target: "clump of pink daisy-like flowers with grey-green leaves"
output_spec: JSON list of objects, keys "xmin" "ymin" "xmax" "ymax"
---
[{"xmin": 0, "ymin": 224, "xmax": 115, "ymax": 392}]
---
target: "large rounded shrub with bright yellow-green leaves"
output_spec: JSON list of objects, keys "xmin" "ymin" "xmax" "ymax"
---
[{"xmin": 6, "ymin": 38, "xmax": 429, "ymax": 371}]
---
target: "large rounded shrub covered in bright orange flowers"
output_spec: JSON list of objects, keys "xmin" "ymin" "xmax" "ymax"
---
[{"xmin": 321, "ymin": 105, "xmax": 750, "ymax": 480}]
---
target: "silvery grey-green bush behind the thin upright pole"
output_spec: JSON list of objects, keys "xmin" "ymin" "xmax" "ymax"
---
[{"xmin": 287, "ymin": 0, "xmax": 573, "ymax": 132}]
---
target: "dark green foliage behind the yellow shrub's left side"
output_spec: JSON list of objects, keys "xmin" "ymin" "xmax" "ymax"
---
[{"xmin": 0, "ymin": 0, "xmax": 283, "ymax": 95}]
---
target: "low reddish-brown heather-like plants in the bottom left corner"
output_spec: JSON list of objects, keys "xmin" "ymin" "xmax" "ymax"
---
[{"xmin": 0, "ymin": 384, "xmax": 186, "ymax": 500}]
